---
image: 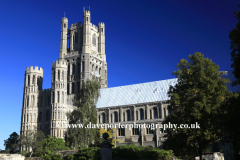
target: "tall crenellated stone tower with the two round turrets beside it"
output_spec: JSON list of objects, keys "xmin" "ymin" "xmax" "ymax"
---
[{"xmin": 20, "ymin": 11, "xmax": 107, "ymax": 138}]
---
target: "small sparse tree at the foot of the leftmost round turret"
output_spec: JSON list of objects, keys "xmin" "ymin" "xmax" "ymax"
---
[{"xmin": 20, "ymin": 130, "xmax": 46, "ymax": 157}]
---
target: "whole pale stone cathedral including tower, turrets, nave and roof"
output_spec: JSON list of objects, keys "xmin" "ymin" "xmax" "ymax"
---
[{"xmin": 20, "ymin": 11, "xmax": 239, "ymax": 147}]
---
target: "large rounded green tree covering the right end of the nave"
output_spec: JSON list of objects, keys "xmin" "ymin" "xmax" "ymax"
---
[{"xmin": 163, "ymin": 52, "xmax": 233, "ymax": 159}]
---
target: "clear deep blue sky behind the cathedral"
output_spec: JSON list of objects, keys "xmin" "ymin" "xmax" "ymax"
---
[{"xmin": 0, "ymin": 0, "xmax": 239, "ymax": 150}]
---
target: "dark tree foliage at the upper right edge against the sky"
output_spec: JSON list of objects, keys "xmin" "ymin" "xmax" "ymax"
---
[{"xmin": 229, "ymin": 4, "xmax": 240, "ymax": 85}]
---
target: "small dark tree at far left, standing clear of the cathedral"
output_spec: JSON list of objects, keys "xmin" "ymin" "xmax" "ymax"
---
[{"xmin": 4, "ymin": 132, "xmax": 19, "ymax": 153}]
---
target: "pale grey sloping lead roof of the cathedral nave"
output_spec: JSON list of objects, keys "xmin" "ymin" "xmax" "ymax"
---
[{"xmin": 97, "ymin": 78, "xmax": 177, "ymax": 108}]
